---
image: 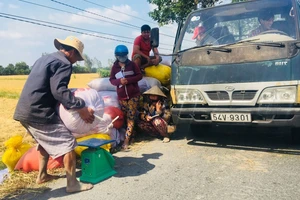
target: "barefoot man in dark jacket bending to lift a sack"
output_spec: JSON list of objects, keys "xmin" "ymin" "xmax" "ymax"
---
[{"xmin": 14, "ymin": 36, "xmax": 94, "ymax": 193}]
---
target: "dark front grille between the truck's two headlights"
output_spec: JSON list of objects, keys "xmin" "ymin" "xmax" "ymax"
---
[{"xmin": 206, "ymin": 90, "xmax": 257, "ymax": 101}]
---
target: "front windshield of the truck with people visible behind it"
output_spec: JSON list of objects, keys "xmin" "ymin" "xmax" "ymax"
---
[{"xmin": 177, "ymin": 0, "xmax": 297, "ymax": 51}]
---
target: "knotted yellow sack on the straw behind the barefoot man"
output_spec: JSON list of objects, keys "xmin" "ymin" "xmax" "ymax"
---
[{"xmin": 2, "ymin": 135, "xmax": 31, "ymax": 171}]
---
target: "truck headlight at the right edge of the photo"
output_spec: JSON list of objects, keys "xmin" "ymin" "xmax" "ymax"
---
[{"xmin": 257, "ymin": 86, "xmax": 297, "ymax": 104}]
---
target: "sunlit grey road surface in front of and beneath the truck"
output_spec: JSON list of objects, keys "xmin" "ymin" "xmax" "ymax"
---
[{"xmin": 15, "ymin": 125, "xmax": 300, "ymax": 200}]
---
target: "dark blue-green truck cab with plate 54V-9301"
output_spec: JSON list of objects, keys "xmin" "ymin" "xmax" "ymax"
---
[{"xmin": 171, "ymin": 0, "xmax": 300, "ymax": 132}]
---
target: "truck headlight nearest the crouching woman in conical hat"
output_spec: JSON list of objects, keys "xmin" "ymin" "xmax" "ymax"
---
[{"xmin": 175, "ymin": 89, "xmax": 205, "ymax": 104}]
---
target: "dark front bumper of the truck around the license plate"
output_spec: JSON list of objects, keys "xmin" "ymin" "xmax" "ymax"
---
[{"xmin": 171, "ymin": 107, "xmax": 300, "ymax": 127}]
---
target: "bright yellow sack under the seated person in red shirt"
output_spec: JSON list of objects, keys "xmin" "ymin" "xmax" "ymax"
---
[{"xmin": 145, "ymin": 64, "xmax": 171, "ymax": 86}]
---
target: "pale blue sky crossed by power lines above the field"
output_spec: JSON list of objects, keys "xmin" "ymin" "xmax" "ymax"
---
[{"xmin": 0, "ymin": 0, "xmax": 177, "ymax": 67}]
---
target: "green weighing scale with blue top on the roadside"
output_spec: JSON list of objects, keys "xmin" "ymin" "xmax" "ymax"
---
[{"xmin": 78, "ymin": 138, "xmax": 117, "ymax": 184}]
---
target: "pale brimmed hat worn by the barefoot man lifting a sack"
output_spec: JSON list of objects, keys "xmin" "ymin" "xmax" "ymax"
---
[{"xmin": 54, "ymin": 36, "xmax": 84, "ymax": 61}]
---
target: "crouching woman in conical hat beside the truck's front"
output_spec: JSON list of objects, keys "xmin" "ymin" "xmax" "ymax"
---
[{"xmin": 137, "ymin": 86, "xmax": 171, "ymax": 142}]
